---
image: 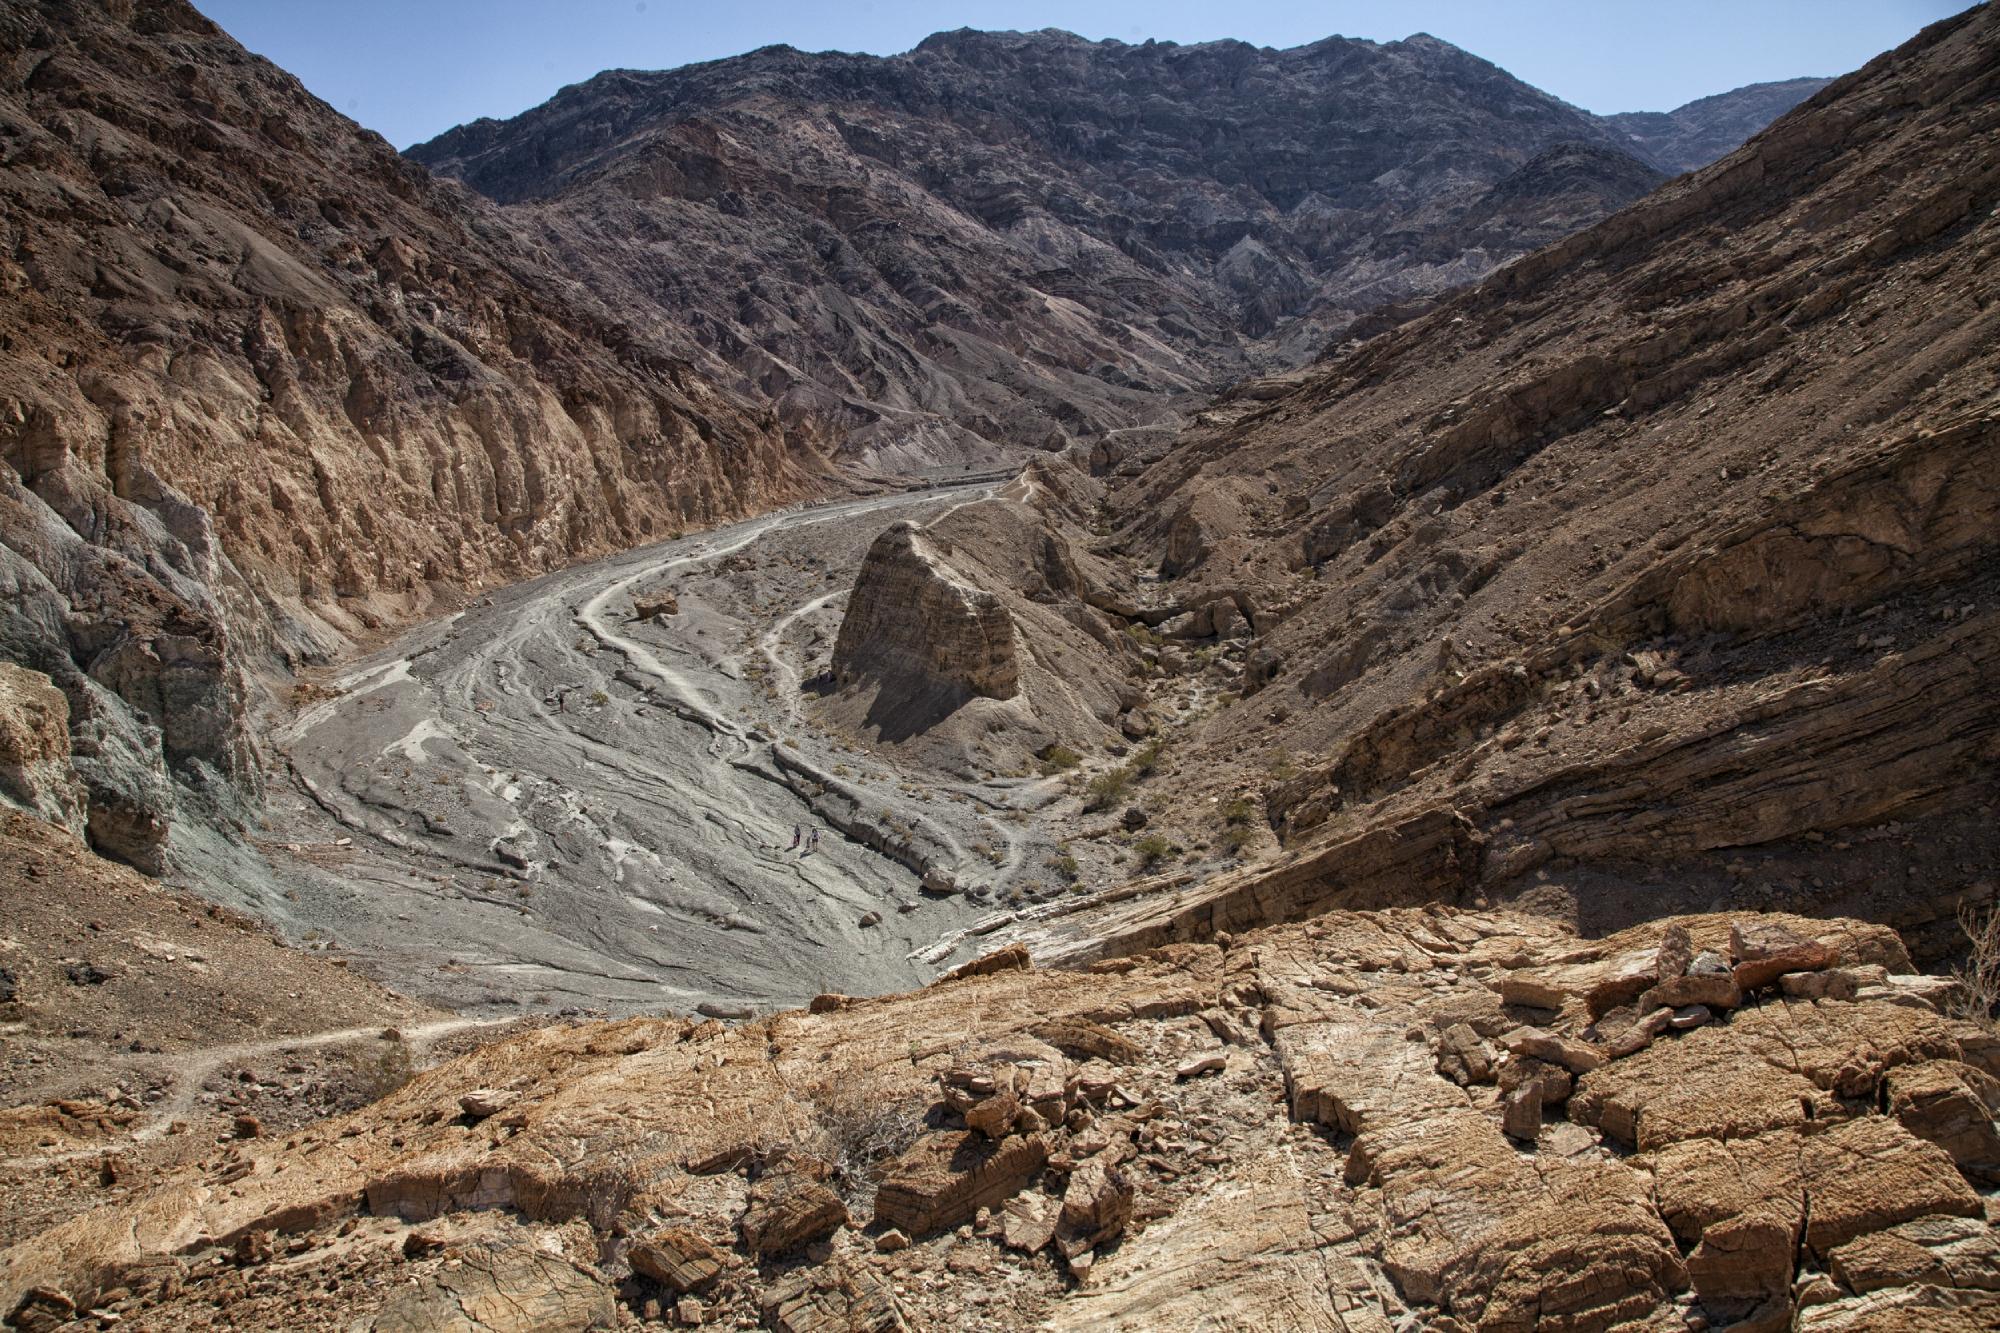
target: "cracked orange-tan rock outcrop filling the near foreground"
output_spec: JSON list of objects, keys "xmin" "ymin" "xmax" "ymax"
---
[{"xmin": 0, "ymin": 909, "xmax": 2000, "ymax": 1331}]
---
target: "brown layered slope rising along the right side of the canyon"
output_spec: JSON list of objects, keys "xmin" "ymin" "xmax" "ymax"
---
[{"xmin": 1048, "ymin": 6, "xmax": 2000, "ymax": 953}]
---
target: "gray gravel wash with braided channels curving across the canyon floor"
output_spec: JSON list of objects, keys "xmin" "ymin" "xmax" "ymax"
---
[{"xmin": 254, "ymin": 488, "xmax": 1046, "ymax": 1017}]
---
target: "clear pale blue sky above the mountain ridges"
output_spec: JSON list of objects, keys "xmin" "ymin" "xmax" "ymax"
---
[{"xmin": 194, "ymin": 0, "xmax": 1966, "ymax": 148}]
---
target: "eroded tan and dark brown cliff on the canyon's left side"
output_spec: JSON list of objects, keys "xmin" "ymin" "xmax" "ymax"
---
[{"xmin": 0, "ymin": 0, "xmax": 818, "ymax": 869}]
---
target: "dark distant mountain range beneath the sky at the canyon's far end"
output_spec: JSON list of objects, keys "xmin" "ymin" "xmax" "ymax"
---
[{"xmin": 410, "ymin": 30, "xmax": 1832, "ymax": 470}]
